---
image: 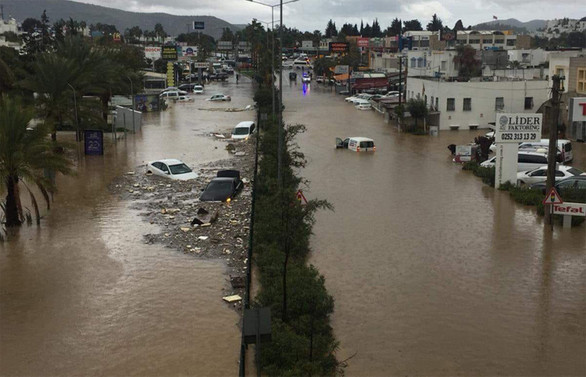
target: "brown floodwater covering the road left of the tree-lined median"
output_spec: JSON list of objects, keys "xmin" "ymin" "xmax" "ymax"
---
[{"xmin": 0, "ymin": 79, "xmax": 255, "ymax": 376}]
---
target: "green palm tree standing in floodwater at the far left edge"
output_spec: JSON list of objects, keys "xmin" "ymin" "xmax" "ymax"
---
[{"xmin": 0, "ymin": 96, "xmax": 71, "ymax": 227}]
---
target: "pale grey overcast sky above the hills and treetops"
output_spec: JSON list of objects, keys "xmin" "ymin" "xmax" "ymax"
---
[{"xmin": 74, "ymin": 0, "xmax": 586, "ymax": 33}]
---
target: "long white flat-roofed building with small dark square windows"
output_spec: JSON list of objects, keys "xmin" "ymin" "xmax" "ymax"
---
[{"xmin": 406, "ymin": 78, "xmax": 549, "ymax": 130}]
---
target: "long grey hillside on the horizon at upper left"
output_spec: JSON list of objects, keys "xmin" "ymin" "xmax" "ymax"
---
[{"xmin": 1, "ymin": 0, "xmax": 241, "ymax": 39}]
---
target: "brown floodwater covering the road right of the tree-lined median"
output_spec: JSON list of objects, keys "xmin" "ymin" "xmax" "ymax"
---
[{"xmin": 283, "ymin": 82, "xmax": 586, "ymax": 376}]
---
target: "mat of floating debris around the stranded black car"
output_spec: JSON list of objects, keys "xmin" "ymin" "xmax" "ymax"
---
[{"xmin": 109, "ymin": 135, "xmax": 255, "ymax": 309}]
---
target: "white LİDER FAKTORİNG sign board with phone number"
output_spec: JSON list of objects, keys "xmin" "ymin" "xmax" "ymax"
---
[{"xmin": 494, "ymin": 113, "xmax": 542, "ymax": 143}]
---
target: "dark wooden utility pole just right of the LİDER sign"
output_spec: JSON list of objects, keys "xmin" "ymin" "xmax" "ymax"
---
[{"xmin": 545, "ymin": 75, "xmax": 562, "ymax": 227}]
